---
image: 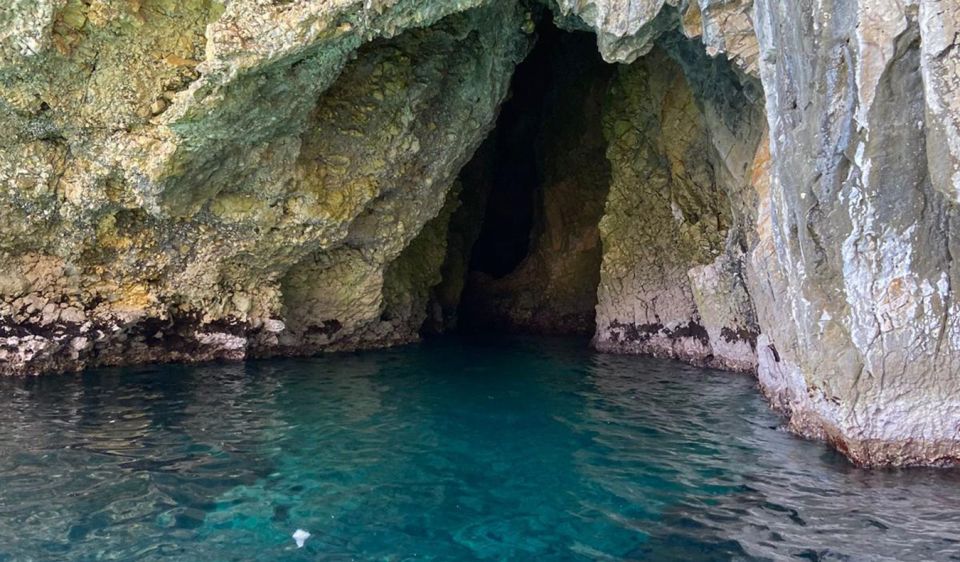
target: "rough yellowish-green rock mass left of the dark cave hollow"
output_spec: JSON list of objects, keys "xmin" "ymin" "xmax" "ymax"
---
[{"xmin": 0, "ymin": 1, "xmax": 529, "ymax": 373}]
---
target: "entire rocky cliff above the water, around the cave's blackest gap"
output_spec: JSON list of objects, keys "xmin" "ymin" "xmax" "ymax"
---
[{"xmin": 0, "ymin": 0, "xmax": 960, "ymax": 464}]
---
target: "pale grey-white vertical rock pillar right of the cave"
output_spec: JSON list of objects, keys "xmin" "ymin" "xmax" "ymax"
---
[{"xmin": 751, "ymin": 0, "xmax": 960, "ymax": 464}]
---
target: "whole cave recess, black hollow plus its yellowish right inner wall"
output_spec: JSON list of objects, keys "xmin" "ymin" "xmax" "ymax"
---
[{"xmin": 423, "ymin": 8, "xmax": 766, "ymax": 371}]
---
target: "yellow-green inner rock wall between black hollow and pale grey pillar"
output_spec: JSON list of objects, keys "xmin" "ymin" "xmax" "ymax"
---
[{"xmin": 594, "ymin": 43, "xmax": 759, "ymax": 371}]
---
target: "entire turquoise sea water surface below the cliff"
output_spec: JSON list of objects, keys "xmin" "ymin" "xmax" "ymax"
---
[{"xmin": 0, "ymin": 339, "xmax": 960, "ymax": 562}]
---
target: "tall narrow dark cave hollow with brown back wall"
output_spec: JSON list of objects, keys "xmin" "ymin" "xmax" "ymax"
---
[{"xmin": 440, "ymin": 18, "xmax": 616, "ymax": 334}]
